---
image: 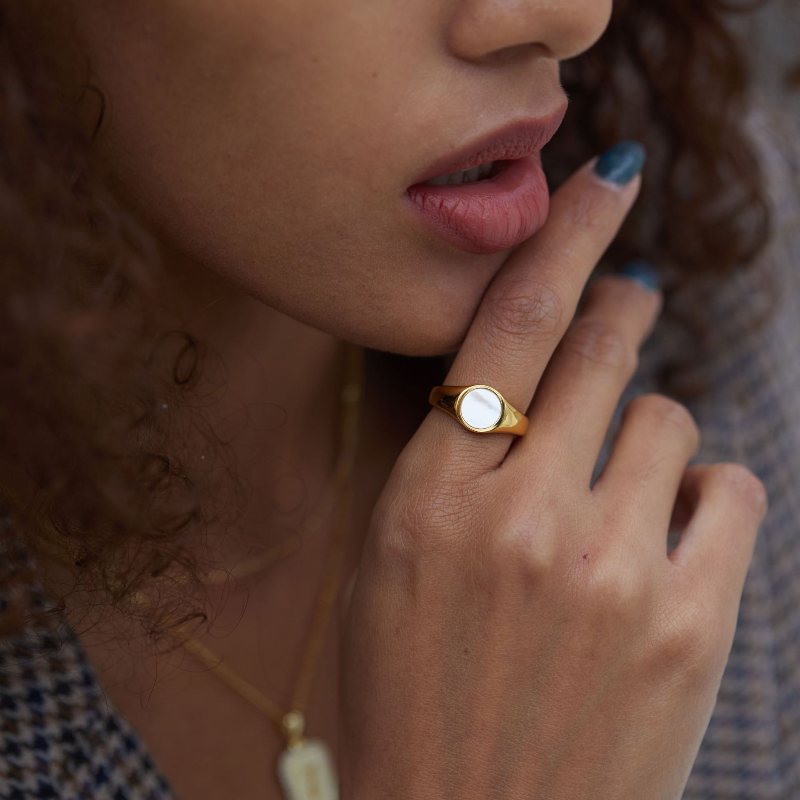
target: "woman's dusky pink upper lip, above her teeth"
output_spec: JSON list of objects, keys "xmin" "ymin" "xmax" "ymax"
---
[{"xmin": 412, "ymin": 102, "xmax": 567, "ymax": 186}]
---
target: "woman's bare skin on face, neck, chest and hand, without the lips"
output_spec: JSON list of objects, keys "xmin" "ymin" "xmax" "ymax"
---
[{"xmin": 7, "ymin": 0, "xmax": 765, "ymax": 800}]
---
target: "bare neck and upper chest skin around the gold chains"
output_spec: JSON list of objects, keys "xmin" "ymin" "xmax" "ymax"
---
[{"xmin": 72, "ymin": 252, "xmax": 418, "ymax": 785}]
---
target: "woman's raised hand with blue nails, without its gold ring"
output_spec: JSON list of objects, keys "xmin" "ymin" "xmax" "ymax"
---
[{"xmin": 340, "ymin": 147, "xmax": 766, "ymax": 800}]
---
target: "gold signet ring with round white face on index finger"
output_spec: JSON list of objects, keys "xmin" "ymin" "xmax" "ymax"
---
[{"xmin": 428, "ymin": 383, "xmax": 528, "ymax": 436}]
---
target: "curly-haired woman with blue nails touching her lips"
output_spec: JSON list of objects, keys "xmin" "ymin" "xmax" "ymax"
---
[{"xmin": 0, "ymin": 0, "xmax": 800, "ymax": 800}]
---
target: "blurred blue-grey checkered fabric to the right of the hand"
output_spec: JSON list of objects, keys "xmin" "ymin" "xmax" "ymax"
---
[{"xmin": 596, "ymin": 106, "xmax": 800, "ymax": 800}]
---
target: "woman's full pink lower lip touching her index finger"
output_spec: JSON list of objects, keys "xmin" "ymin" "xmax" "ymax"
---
[{"xmin": 406, "ymin": 153, "xmax": 550, "ymax": 255}]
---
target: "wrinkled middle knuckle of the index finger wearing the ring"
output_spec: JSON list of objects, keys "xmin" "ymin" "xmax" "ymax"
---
[{"xmin": 488, "ymin": 278, "xmax": 567, "ymax": 341}]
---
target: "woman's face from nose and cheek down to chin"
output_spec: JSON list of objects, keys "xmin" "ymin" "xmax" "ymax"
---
[{"xmin": 50, "ymin": 0, "xmax": 611, "ymax": 355}]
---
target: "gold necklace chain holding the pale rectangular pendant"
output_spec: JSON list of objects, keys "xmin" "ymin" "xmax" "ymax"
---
[{"xmin": 177, "ymin": 343, "xmax": 364, "ymax": 768}]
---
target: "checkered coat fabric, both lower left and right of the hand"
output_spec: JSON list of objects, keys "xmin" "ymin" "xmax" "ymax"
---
[{"xmin": 0, "ymin": 103, "xmax": 800, "ymax": 800}]
